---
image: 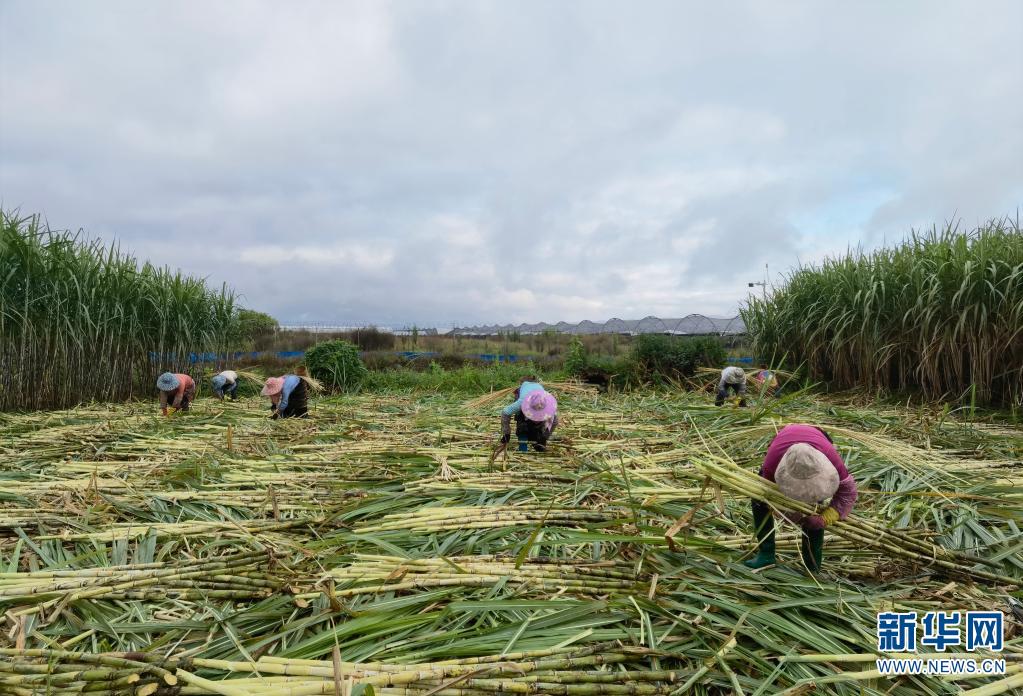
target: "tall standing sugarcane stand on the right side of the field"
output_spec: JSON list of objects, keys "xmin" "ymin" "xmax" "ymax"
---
[{"xmin": 742, "ymin": 219, "xmax": 1023, "ymax": 405}]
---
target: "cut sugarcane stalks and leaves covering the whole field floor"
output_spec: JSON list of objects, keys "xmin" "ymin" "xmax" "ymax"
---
[{"xmin": 0, "ymin": 385, "xmax": 1023, "ymax": 696}]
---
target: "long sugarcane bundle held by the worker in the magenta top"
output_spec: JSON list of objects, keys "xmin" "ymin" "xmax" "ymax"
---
[{"xmin": 694, "ymin": 454, "xmax": 1021, "ymax": 586}]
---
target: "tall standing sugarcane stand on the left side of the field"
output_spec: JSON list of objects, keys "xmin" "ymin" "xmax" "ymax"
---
[{"xmin": 0, "ymin": 211, "xmax": 235, "ymax": 410}]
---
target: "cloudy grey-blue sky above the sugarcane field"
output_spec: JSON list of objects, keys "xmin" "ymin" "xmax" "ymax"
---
[{"xmin": 0, "ymin": 0, "xmax": 1023, "ymax": 325}]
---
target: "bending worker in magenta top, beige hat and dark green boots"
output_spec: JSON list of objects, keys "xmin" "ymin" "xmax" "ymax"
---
[{"xmin": 746, "ymin": 425, "xmax": 856, "ymax": 571}]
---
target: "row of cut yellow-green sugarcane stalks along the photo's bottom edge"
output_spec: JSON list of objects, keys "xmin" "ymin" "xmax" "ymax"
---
[{"xmin": 0, "ymin": 644, "xmax": 685, "ymax": 696}]
